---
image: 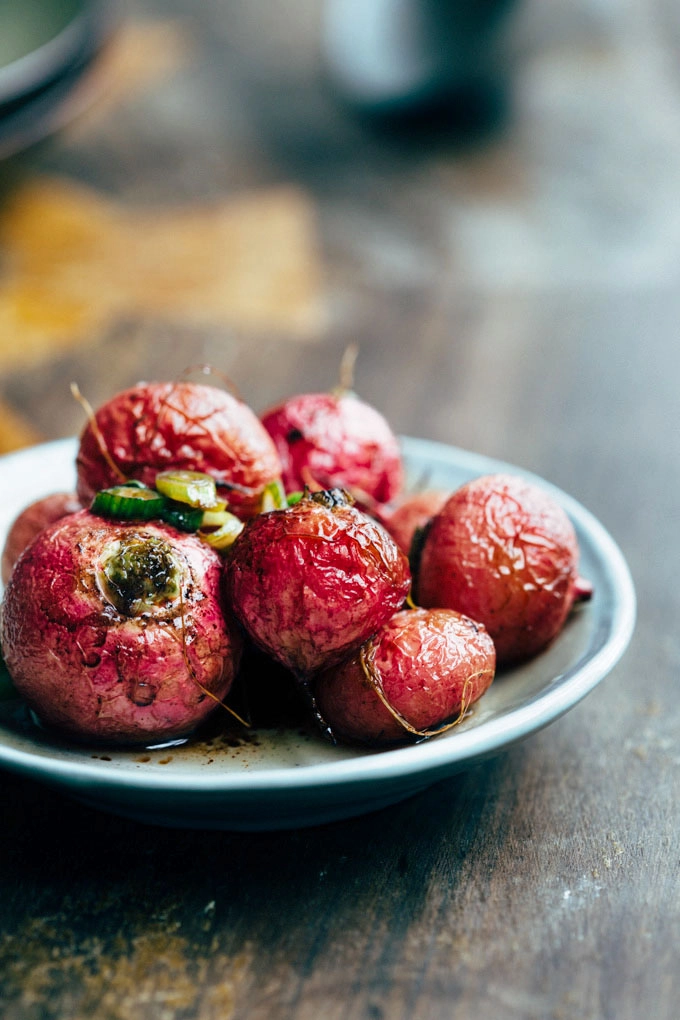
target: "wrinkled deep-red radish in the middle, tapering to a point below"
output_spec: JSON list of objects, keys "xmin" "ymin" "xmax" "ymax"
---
[{"xmin": 225, "ymin": 491, "xmax": 411, "ymax": 677}]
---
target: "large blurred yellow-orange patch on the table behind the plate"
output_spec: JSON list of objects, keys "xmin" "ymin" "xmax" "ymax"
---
[{"xmin": 0, "ymin": 179, "xmax": 322, "ymax": 366}]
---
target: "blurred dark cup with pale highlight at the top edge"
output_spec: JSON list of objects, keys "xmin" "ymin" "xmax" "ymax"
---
[{"xmin": 322, "ymin": 0, "xmax": 514, "ymax": 132}]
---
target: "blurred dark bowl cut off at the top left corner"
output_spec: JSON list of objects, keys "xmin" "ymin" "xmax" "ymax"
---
[{"xmin": 0, "ymin": 0, "xmax": 116, "ymax": 159}]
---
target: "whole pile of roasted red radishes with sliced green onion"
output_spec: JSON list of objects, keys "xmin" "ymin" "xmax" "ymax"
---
[{"xmin": 1, "ymin": 381, "xmax": 589, "ymax": 747}]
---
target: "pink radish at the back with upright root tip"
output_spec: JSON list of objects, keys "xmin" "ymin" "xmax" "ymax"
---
[{"xmin": 262, "ymin": 392, "xmax": 403, "ymax": 509}]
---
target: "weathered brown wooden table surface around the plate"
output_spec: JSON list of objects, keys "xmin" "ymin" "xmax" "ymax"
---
[{"xmin": 0, "ymin": 0, "xmax": 680, "ymax": 1020}]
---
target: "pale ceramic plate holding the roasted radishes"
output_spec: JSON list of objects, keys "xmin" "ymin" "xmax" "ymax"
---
[{"xmin": 0, "ymin": 439, "xmax": 635, "ymax": 830}]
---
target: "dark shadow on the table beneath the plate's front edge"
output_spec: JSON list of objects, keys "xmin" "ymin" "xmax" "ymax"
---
[{"xmin": 0, "ymin": 752, "xmax": 517, "ymax": 927}]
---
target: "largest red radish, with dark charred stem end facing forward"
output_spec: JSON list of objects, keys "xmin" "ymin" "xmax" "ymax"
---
[{"xmin": 2, "ymin": 511, "xmax": 240, "ymax": 744}]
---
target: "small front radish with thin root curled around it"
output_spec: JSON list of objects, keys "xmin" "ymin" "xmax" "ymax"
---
[{"xmin": 315, "ymin": 609, "xmax": 495, "ymax": 747}]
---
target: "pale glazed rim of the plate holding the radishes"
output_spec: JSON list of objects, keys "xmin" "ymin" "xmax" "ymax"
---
[{"xmin": 0, "ymin": 436, "xmax": 636, "ymax": 797}]
